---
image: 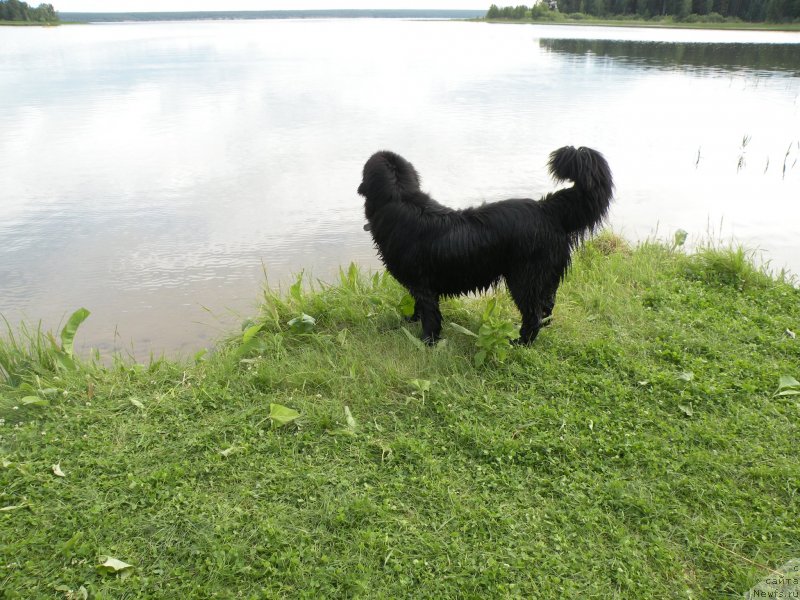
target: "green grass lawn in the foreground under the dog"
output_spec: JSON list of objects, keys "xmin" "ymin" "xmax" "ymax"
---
[{"xmin": 0, "ymin": 235, "xmax": 800, "ymax": 600}]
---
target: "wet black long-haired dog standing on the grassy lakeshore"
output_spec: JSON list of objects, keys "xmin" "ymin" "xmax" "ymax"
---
[{"xmin": 358, "ymin": 146, "xmax": 614, "ymax": 344}]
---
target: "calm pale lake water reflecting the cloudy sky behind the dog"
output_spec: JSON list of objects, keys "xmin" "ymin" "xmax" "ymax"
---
[{"xmin": 0, "ymin": 19, "xmax": 800, "ymax": 357}]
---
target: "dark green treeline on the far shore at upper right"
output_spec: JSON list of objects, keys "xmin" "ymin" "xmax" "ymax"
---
[{"xmin": 486, "ymin": 0, "xmax": 800, "ymax": 23}]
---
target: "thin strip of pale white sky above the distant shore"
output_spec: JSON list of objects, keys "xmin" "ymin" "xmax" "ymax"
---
[{"xmin": 54, "ymin": 0, "xmax": 491, "ymax": 12}]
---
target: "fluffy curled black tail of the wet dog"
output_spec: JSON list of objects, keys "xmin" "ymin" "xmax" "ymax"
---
[{"xmin": 543, "ymin": 146, "xmax": 614, "ymax": 241}]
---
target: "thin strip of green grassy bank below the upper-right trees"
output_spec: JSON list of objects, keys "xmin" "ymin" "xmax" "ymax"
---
[{"xmin": 476, "ymin": 13, "xmax": 800, "ymax": 31}]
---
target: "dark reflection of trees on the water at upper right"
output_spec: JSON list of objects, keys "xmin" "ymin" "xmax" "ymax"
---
[{"xmin": 539, "ymin": 38, "xmax": 800, "ymax": 75}]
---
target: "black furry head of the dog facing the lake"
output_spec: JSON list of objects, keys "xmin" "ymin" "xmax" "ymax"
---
[{"xmin": 358, "ymin": 150, "xmax": 419, "ymax": 224}]
